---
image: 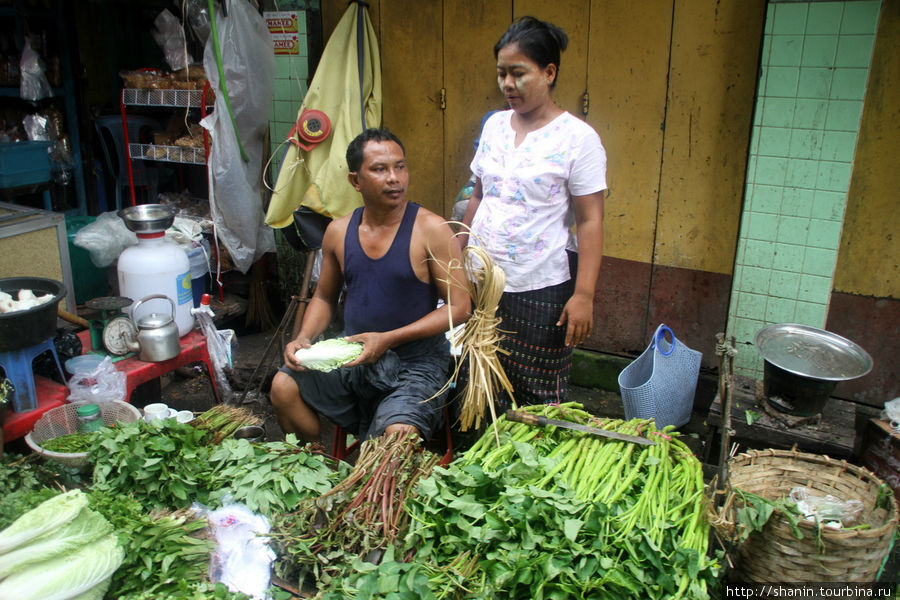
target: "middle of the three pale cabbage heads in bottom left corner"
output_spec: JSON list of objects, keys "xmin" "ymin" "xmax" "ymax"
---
[{"xmin": 0, "ymin": 508, "xmax": 112, "ymax": 579}]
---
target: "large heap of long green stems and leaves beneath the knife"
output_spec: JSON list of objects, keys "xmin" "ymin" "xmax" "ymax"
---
[{"xmin": 322, "ymin": 404, "xmax": 719, "ymax": 600}]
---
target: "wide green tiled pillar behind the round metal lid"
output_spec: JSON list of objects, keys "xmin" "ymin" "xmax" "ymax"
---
[{"xmin": 728, "ymin": 0, "xmax": 881, "ymax": 378}]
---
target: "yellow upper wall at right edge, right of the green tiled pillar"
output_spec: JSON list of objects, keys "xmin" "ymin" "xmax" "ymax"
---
[{"xmin": 834, "ymin": 0, "xmax": 900, "ymax": 299}]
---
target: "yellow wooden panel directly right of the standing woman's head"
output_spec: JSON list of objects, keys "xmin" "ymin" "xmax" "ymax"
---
[{"xmin": 587, "ymin": 0, "xmax": 672, "ymax": 263}]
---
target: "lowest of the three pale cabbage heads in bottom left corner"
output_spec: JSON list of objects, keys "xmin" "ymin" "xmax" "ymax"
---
[{"xmin": 0, "ymin": 535, "xmax": 125, "ymax": 600}]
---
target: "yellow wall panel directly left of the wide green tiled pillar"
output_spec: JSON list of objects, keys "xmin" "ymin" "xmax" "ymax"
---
[{"xmin": 653, "ymin": 0, "xmax": 765, "ymax": 274}]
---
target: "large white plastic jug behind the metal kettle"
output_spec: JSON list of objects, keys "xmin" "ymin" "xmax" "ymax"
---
[{"xmin": 117, "ymin": 232, "xmax": 194, "ymax": 337}]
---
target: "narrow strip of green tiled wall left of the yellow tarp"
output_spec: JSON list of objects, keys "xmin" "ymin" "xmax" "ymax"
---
[{"xmin": 268, "ymin": 11, "xmax": 310, "ymax": 184}]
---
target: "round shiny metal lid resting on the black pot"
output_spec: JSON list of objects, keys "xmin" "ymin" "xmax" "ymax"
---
[{"xmin": 753, "ymin": 323, "xmax": 873, "ymax": 381}]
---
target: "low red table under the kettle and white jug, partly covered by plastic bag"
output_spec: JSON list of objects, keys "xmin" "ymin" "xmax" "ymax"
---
[{"xmin": 3, "ymin": 329, "xmax": 219, "ymax": 442}]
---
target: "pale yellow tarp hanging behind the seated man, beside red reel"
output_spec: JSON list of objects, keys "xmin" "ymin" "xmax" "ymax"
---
[{"xmin": 266, "ymin": 2, "xmax": 381, "ymax": 228}]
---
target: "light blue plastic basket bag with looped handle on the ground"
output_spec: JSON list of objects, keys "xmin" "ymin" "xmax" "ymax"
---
[{"xmin": 619, "ymin": 325, "xmax": 703, "ymax": 427}]
